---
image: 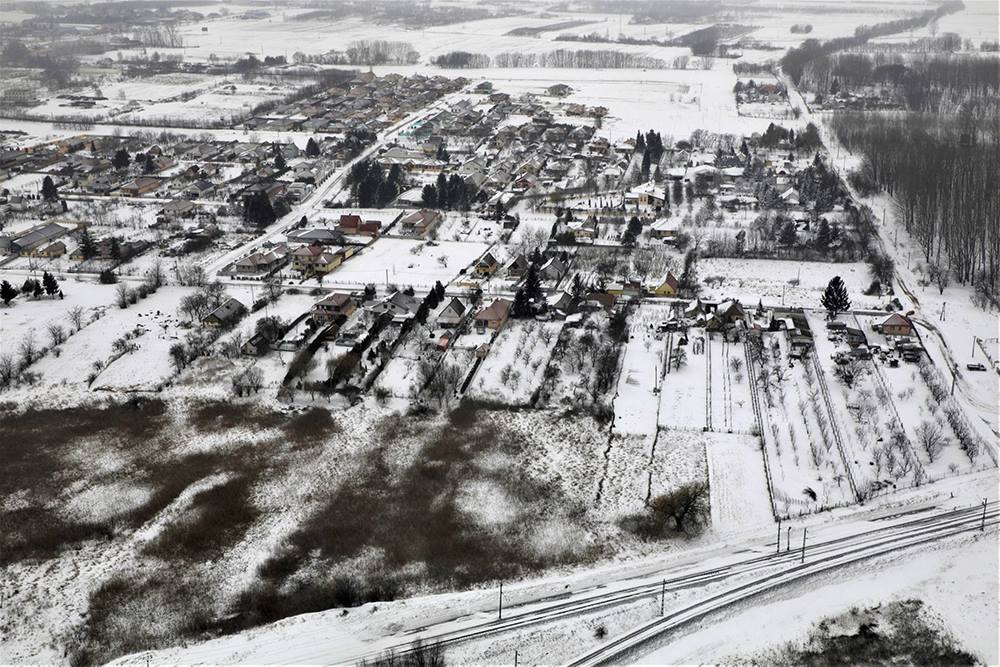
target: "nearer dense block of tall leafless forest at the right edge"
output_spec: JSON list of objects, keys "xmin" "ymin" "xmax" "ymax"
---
[{"xmin": 831, "ymin": 113, "xmax": 1000, "ymax": 303}]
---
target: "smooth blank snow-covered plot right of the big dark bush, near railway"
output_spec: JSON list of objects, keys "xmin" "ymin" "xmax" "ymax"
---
[{"xmin": 705, "ymin": 433, "xmax": 774, "ymax": 533}]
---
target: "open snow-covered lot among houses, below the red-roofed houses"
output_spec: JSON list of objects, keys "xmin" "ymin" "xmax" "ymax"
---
[{"xmin": 324, "ymin": 238, "xmax": 489, "ymax": 289}]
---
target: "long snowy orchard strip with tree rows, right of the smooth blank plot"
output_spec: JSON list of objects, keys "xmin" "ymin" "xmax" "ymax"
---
[{"xmin": 751, "ymin": 334, "xmax": 856, "ymax": 516}]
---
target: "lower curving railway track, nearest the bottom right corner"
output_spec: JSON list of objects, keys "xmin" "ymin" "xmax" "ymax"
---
[{"xmin": 567, "ymin": 509, "xmax": 1000, "ymax": 667}]
